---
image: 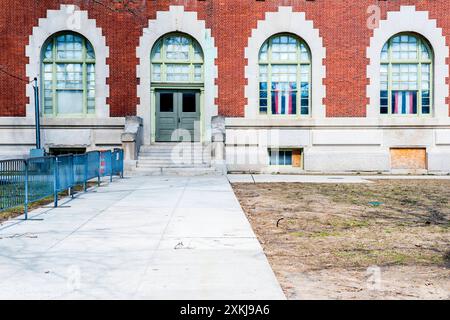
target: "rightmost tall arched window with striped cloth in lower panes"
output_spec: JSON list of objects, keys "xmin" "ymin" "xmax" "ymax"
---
[{"xmin": 380, "ymin": 33, "xmax": 433, "ymax": 115}]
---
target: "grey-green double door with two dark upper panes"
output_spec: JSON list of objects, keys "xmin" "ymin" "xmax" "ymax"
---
[{"xmin": 156, "ymin": 89, "xmax": 200, "ymax": 142}]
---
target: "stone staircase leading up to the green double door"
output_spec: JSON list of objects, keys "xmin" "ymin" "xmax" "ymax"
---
[{"xmin": 136, "ymin": 143, "xmax": 221, "ymax": 175}]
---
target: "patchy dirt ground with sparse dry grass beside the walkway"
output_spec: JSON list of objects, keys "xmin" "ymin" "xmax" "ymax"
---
[{"xmin": 233, "ymin": 180, "xmax": 450, "ymax": 299}]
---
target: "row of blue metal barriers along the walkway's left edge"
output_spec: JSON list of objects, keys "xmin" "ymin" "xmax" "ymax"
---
[{"xmin": 0, "ymin": 149, "xmax": 124, "ymax": 219}]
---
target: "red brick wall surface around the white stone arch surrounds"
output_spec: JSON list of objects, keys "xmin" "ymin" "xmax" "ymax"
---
[{"xmin": 0, "ymin": 0, "xmax": 450, "ymax": 117}]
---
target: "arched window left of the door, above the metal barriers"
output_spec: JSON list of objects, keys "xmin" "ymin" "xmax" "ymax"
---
[{"xmin": 41, "ymin": 32, "xmax": 95, "ymax": 116}]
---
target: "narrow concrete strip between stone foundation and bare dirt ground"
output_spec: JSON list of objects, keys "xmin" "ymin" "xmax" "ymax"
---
[{"xmin": 228, "ymin": 174, "xmax": 450, "ymax": 183}]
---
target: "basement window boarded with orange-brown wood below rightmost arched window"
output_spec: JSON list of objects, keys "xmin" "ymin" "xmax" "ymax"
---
[{"xmin": 391, "ymin": 148, "xmax": 427, "ymax": 170}]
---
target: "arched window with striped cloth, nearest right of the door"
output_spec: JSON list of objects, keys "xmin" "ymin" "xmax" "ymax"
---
[{"xmin": 259, "ymin": 34, "xmax": 311, "ymax": 115}]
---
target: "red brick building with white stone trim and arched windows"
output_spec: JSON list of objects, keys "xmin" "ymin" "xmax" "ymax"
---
[{"xmin": 0, "ymin": 0, "xmax": 450, "ymax": 172}]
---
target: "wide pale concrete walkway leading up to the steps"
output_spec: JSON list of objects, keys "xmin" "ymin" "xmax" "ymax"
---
[{"xmin": 0, "ymin": 177, "xmax": 285, "ymax": 299}]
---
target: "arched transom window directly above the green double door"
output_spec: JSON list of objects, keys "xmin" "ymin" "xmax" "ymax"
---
[{"xmin": 151, "ymin": 33, "xmax": 204, "ymax": 84}]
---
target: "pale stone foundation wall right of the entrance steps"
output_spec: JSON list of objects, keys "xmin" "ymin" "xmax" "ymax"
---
[{"xmin": 225, "ymin": 118, "xmax": 450, "ymax": 174}]
